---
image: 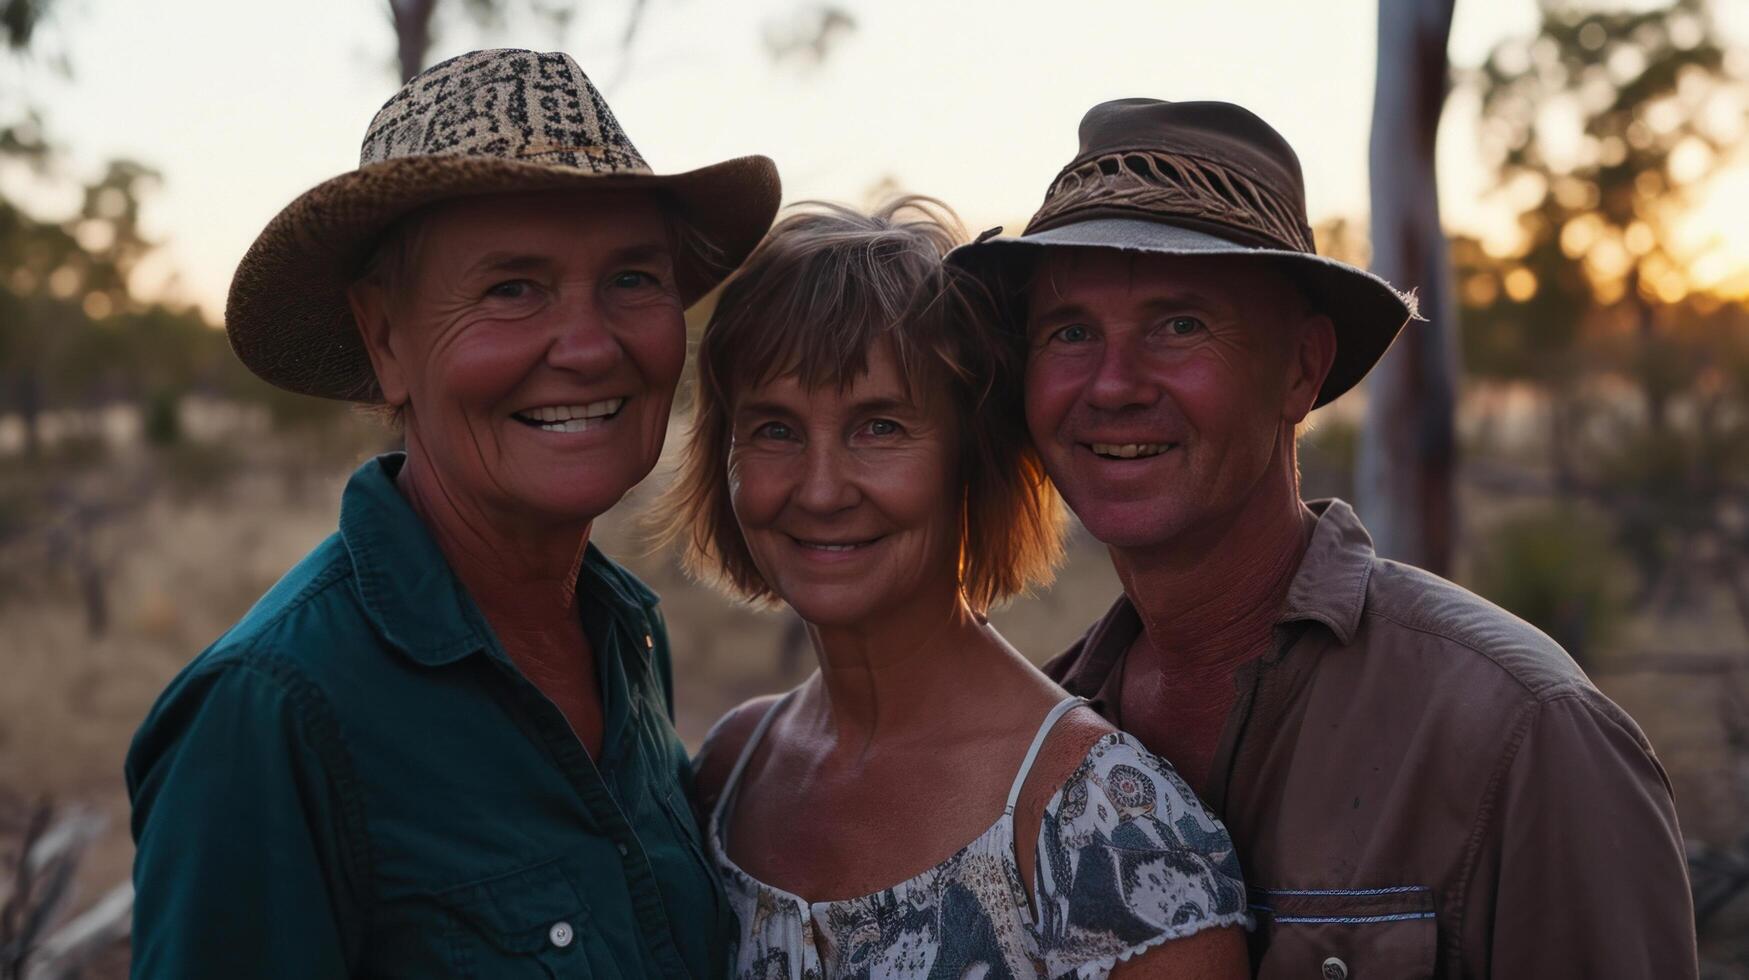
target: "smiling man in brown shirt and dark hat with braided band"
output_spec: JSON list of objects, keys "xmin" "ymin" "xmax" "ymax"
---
[{"xmin": 953, "ymin": 100, "xmax": 1697, "ymax": 980}]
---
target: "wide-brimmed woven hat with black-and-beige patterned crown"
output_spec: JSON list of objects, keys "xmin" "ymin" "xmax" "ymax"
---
[{"xmin": 224, "ymin": 49, "xmax": 782, "ymax": 401}]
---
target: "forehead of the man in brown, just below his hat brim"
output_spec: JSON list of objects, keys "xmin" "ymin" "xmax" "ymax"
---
[{"xmin": 1025, "ymin": 249, "xmax": 1300, "ymax": 315}]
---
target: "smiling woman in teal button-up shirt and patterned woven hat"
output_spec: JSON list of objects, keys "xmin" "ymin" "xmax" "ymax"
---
[{"xmin": 126, "ymin": 51, "xmax": 778, "ymax": 978}]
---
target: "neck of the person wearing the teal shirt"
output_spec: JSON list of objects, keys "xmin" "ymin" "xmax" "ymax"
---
[{"xmin": 395, "ymin": 442, "xmax": 589, "ymax": 646}]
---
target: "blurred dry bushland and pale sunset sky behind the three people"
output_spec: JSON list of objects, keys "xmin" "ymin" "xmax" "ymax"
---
[{"xmin": 0, "ymin": 0, "xmax": 1749, "ymax": 978}]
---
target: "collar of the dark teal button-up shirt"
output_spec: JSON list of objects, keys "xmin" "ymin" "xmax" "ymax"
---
[{"xmin": 339, "ymin": 453, "xmax": 656, "ymax": 667}]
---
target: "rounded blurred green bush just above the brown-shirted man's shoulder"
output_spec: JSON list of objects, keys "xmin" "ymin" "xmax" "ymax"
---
[{"xmin": 1471, "ymin": 506, "xmax": 1627, "ymax": 667}]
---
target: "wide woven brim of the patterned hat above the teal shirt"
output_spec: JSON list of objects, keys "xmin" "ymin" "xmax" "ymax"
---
[{"xmin": 224, "ymin": 156, "xmax": 782, "ymax": 403}]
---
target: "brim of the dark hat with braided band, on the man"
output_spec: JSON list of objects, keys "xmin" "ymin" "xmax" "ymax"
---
[{"xmin": 948, "ymin": 217, "xmax": 1418, "ymax": 406}]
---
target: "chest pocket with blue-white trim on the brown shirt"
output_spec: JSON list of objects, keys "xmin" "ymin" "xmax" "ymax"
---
[{"xmin": 1251, "ymin": 886, "xmax": 1439, "ymax": 980}]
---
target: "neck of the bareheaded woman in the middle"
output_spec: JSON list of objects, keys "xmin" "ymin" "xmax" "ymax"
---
[{"xmin": 808, "ymin": 577, "xmax": 1018, "ymax": 753}]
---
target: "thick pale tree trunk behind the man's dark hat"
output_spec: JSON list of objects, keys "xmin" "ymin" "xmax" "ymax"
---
[{"xmin": 1355, "ymin": 0, "xmax": 1457, "ymax": 574}]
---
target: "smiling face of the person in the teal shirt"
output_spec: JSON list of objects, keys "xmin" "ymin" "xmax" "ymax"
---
[{"xmin": 353, "ymin": 191, "xmax": 686, "ymax": 523}]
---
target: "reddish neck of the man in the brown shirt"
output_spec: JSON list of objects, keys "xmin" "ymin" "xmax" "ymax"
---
[{"xmin": 1112, "ymin": 444, "xmax": 1317, "ymax": 683}]
